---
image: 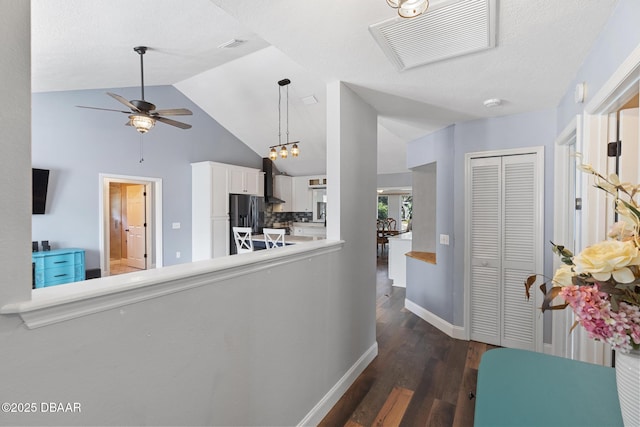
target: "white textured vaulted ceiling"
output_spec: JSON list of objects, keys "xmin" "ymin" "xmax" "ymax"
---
[{"xmin": 31, "ymin": 0, "xmax": 617, "ymax": 175}]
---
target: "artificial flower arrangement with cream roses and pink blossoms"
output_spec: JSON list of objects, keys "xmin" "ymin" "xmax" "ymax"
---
[{"xmin": 525, "ymin": 159, "xmax": 640, "ymax": 353}]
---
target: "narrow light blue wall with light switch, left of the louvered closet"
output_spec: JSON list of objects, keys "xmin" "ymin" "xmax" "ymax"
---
[{"xmin": 406, "ymin": 126, "xmax": 455, "ymax": 323}]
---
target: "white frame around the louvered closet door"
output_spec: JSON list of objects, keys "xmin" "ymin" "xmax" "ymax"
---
[{"xmin": 464, "ymin": 146, "xmax": 545, "ymax": 352}]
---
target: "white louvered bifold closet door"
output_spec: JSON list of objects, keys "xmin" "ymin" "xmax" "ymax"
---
[{"xmin": 470, "ymin": 154, "xmax": 542, "ymax": 350}]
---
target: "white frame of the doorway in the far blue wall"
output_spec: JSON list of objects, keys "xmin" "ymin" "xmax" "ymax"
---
[{"xmin": 98, "ymin": 173, "xmax": 163, "ymax": 277}]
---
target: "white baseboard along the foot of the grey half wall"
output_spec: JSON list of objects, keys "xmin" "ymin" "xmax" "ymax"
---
[{"xmin": 298, "ymin": 342, "xmax": 378, "ymax": 426}]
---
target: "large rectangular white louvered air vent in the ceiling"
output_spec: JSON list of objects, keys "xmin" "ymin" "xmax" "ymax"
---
[{"xmin": 369, "ymin": 0, "xmax": 496, "ymax": 71}]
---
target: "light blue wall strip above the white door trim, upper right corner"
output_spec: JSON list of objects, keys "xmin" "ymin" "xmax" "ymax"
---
[{"xmin": 557, "ymin": 0, "xmax": 640, "ymax": 133}]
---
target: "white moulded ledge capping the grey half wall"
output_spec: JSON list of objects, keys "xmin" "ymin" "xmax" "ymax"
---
[{"xmin": 0, "ymin": 240, "xmax": 343, "ymax": 329}]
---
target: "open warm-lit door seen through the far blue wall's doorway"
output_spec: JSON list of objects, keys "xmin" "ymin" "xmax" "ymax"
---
[{"xmin": 127, "ymin": 185, "xmax": 147, "ymax": 269}]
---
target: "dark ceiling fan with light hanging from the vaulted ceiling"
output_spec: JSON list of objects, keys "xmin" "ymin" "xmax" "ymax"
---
[{"xmin": 77, "ymin": 46, "xmax": 193, "ymax": 133}]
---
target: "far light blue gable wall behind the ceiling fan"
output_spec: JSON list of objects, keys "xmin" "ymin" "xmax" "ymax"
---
[{"xmin": 32, "ymin": 86, "xmax": 262, "ymax": 268}]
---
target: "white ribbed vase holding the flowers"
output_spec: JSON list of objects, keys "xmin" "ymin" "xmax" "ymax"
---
[{"xmin": 616, "ymin": 350, "xmax": 640, "ymax": 427}]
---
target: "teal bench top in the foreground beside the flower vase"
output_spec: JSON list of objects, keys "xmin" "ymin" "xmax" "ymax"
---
[{"xmin": 474, "ymin": 348, "xmax": 623, "ymax": 427}]
